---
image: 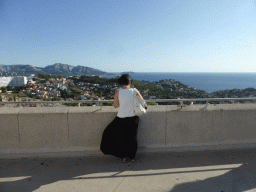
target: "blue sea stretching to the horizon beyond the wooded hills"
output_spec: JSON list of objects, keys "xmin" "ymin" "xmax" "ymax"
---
[{"xmin": 102, "ymin": 72, "xmax": 256, "ymax": 93}]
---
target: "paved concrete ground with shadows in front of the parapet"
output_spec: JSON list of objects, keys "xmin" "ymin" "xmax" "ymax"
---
[{"xmin": 0, "ymin": 149, "xmax": 256, "ymax": 192}]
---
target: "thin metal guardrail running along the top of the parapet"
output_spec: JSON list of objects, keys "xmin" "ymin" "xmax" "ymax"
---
[{"xmin": 0, "ymin": 97, "xmax": 256, "ymax": 108}]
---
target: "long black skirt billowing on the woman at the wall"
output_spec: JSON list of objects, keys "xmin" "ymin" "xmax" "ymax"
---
[{"xmin": 100, "ymin": 116, "xmax": 139, "ymax": 159}]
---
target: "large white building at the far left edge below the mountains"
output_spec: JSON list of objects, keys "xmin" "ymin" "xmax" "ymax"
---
[{"xmin": 0, "ymin": 76, "xmax": 28, "ymax": 87}]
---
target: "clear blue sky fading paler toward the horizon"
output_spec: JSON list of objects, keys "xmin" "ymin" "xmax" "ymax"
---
[{"xmin": 0, "ymin": 0, "xmax": 256, "ymax": 72}]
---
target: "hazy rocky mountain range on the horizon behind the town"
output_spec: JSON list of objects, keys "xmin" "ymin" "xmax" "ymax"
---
[{"xmin": 0, "ymin": 63, "xmax": 117, "ymax": 76}]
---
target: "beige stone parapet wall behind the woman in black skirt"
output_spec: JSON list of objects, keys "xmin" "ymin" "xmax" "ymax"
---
[{"xmin": 0, "ymin": 104, "xmax": 256, "ymax": 158}]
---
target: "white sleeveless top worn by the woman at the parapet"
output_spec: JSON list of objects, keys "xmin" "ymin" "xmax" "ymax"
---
[{"xmin": 117, "ymin": 88, "xmax": 135, "ymax": 118}]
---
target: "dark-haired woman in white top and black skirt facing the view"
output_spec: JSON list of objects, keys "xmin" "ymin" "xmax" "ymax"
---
[{"xmin": 100, "ymin": 74, "xmax": 147, "ymax": 163}]
